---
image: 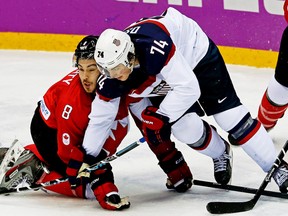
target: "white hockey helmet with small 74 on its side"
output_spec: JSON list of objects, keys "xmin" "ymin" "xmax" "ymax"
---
[{"xmin": 94, "ymin": 29, "xmax": 135, "ymax": 77}]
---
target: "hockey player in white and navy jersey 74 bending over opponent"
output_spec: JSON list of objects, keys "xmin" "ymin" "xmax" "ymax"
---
[{"xmin": 89, "ymin": 8, "xmax": 288, "ymax": 192}]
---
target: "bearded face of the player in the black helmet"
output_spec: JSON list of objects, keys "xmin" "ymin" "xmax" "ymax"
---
[{"xmin": 78, "ymin": 59, "xmax": 100, "ymax": 93}]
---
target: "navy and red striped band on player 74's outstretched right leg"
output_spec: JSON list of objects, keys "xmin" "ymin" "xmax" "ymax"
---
[{"xmin": 228, "ymin": 113, "xmax": 261, "ymax": 145}]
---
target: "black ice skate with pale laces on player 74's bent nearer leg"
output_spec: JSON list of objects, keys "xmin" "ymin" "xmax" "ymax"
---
[{"xmin": 213, "ymin": 141, "xmax": 233, "ymax": 185}]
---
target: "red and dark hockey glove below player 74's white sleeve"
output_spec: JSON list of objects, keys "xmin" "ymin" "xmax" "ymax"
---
[{"xmin": 141, "ymin": 106, "xmax": 171, "ymax": 145}]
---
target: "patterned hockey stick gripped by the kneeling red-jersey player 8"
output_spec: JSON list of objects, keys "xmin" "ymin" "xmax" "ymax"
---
[{"xmin": 0, "ymin": 138, "xmax": 145, "ymax": 195}]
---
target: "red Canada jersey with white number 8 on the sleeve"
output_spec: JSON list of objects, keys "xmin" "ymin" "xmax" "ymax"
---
[{"xmin": 40, "ymin": 70, "xmax": 128, "ymax": 163}]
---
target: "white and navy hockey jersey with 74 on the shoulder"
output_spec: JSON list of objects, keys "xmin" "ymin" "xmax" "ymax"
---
[{"xmin": 84, "ymin": 8, "xmax": 209, "ymax": 152}]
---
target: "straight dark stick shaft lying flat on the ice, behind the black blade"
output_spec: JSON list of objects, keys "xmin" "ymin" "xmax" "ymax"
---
[{"xmin": 193, "ymin": 179, "xmax": 288, "ymax": 199}]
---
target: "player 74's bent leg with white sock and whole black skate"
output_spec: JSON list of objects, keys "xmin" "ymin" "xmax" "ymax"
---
[{"xmin": 172, "ymin": 113, "xmax": 233, "ymax": 184}]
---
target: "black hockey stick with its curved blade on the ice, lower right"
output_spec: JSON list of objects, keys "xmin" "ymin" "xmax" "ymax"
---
[{"xmin": 206, "ymin": 141, "xmax": 288, "ymax": 214}]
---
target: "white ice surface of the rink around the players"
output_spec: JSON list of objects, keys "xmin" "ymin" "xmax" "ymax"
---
[{"xmin": 0, "ymin": 50, "xmax": 288, "ymax": 216}]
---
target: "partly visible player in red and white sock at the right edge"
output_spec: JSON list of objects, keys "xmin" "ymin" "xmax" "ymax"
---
[{"xmin": 258, "ymin": 0, "xmax": 288, "ymax": 131}]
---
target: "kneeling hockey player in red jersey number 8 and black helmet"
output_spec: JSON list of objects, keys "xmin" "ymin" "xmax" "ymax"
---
[{"xmin": 0, "ymin": 36, "xmax": 130, "ymax": 210}]
